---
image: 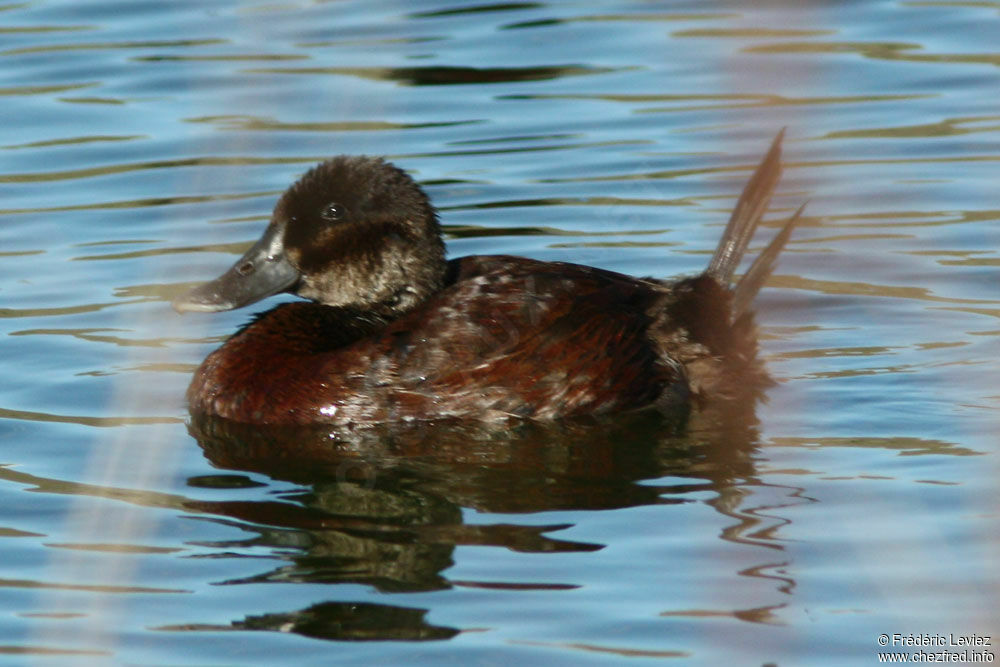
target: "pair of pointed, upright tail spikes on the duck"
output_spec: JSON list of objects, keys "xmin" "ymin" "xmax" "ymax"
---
[{"xmin": 705, "ymin": 130, "xmax": 805, "ymax": 320}]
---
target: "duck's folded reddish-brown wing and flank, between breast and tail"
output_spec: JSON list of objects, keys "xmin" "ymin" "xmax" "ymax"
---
[{"xmin": 378, "ymin": 256, "xmax": 683, "ymax": 419}]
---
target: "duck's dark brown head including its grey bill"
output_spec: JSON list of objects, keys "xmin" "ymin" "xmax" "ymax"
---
[{"xmin": 173, "ymin": 156, "xmax": 446, "ymax": 318}]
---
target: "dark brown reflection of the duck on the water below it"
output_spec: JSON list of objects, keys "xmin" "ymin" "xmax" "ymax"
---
[{"xmin": 182, "ymin": 392, "xmax": 772, "ymax": 639}]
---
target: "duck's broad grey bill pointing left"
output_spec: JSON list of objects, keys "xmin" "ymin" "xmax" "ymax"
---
[{"xmin": 173, "ymin": 226, "xmax": 299, "ymax": 313}]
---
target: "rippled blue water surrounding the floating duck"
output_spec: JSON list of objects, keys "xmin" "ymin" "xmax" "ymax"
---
[{"xmin": 0, "ymin": 0, "xmax": 1000, "ymax": 665}]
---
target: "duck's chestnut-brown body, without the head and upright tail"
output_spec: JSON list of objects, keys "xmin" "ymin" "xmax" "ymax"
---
[{"xmin": 188, "ymin": 256, "xmax": 688, "ymax": 424}]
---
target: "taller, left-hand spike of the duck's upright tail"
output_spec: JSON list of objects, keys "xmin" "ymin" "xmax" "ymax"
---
[{"xmin": 705, "ymin": 129, "xmax": 785, "ymax": 286}]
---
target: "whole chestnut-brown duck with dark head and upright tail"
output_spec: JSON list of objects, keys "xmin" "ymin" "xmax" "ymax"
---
[{"xmin": 173, "ymin": 130, "xmax": 802, "ymax": 429}]
